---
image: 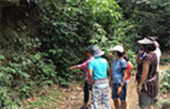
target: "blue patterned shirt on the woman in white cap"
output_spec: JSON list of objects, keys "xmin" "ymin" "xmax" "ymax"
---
[{"xmin": 112, "ymin": 58, "xmax": 127, "ymax": 84}]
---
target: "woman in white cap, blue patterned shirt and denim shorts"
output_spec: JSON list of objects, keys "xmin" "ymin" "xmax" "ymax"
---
[{"xmin": 110, "ymin": 45, "xmax": 127, "ymax": 109}]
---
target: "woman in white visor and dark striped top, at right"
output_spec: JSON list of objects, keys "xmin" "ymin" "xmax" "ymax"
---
[{"xmin": 136, "ymin": 38, "xmax": 158, "ymax": 109}]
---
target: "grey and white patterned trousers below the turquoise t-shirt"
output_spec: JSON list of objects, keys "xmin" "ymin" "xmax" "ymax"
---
[{"xmin": 90, "ymin": 79, "xmax": 111, "ymax": 109}]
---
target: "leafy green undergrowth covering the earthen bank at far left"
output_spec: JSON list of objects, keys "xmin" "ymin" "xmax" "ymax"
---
[{"xmin": 0, "ymin": 7, "xmax": 58, "ymax": 109}]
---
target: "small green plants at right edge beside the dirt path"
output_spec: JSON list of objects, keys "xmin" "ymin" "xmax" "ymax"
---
[{"xmin": 161, "ymin": 68, "xmax": 170, "ymax": 93}]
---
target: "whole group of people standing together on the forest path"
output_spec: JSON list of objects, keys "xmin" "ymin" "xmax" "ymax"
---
[{"xmin": 69, "ymin": 37, "xmax": 161, "ymax": 109}]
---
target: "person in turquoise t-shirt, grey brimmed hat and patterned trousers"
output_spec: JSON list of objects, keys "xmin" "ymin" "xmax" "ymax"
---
[{"xmin": 89, "ymin": 46, "xmax": 111, "ymax": 109}]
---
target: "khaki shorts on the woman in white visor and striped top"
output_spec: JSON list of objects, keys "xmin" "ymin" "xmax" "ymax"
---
[{"xmin": 139, "ymin": 91, "xmax": 154, "ymax": 109}]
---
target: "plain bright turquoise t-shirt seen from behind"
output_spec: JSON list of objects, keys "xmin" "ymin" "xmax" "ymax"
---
[{"xmin": 89, "ymin": 57, "xmax": 109, "ymax": 80}]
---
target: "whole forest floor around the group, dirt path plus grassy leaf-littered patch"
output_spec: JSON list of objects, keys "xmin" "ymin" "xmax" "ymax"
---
[{"xmin": 21, "ymin": 53, "xmax": 170, "ymax": 109}]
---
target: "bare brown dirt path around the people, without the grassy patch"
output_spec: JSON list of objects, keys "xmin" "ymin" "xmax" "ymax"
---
[{"xmin": 55, "ymin": 65, "xmax": 169, "ymax": 109}]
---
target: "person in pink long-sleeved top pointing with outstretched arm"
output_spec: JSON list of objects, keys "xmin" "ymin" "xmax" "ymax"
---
[{"xmin": 69, "ymin": 46, "xmax": 93, "ymax": 109}]
